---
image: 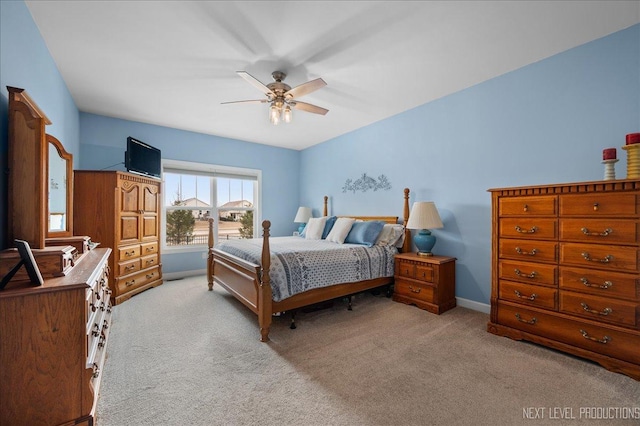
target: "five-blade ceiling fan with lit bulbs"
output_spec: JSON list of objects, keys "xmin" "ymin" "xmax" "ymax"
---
[{"xmin": 222, "ymin": 71, "xmax": 329, "ymax": 125}]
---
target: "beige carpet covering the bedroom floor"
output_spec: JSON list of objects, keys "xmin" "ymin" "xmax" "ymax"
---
[{"xmin": 97, "ymin": 276, "xmax": 640, "ymax": 426}]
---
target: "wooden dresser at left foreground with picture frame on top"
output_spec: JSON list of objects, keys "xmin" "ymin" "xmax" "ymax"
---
[{"xmin": 0, "ymin": 248, "xmax": 111, "ymax": 426}]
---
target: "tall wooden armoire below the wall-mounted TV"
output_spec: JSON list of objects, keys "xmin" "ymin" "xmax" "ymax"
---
[{"xmin": 73, "ymin": 170, "xmax": 162, "ymax": 305}]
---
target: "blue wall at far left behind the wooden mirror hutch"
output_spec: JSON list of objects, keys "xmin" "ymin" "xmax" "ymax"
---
[{"xmin": 0, "ymin": 1, "xmax": 80, "ymax": 248}]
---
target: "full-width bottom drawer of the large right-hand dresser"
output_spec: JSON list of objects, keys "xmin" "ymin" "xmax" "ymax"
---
[{"xmin": 498, "ymin": 301, "xmax": 640, "ymax": 364}]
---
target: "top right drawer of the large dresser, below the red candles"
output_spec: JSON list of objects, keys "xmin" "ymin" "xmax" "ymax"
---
[{"xmin": 560, "ymin": 193, "xmax": 638, "ymax": 217}]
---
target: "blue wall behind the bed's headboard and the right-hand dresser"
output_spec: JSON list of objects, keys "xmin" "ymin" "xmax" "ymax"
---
[{"xmin": 300, "ymin": 25, "xmax": 640, "ymax": 303}]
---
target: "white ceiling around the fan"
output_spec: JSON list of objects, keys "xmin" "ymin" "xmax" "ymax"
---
[{"xmin": 26, "ymin": 0, "xmax": 640, "ymax": 149}]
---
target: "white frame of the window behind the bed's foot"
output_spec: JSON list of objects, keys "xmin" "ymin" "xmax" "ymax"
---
[{"xmin": 160, "ymin": 159, "xmax": 262, "ymax": 254}]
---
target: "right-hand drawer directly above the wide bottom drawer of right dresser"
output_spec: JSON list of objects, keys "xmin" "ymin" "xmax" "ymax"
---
[{"xmin": 560, "ymin": 291, "xmax": 639, "ymax": 327}]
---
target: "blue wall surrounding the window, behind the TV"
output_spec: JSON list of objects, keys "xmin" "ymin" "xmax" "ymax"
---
[{"xmin": 79, "ymin": 113, "xmax": 300, "ymax": 273}]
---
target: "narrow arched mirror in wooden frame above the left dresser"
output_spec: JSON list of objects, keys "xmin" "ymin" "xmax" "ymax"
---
[{"xmin": 46, "ymin": 135, "xmax": 73, "ymax": 237}]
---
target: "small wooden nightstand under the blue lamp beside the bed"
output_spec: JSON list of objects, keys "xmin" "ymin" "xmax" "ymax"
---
[{"xmin": 393, "ymin": 253, "xmax": 456, "ymax": 314}]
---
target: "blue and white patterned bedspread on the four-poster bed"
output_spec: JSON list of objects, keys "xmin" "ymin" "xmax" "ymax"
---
[{"xmin": 215, "ymin": 237, "xmax": 398, "ymax": 302}]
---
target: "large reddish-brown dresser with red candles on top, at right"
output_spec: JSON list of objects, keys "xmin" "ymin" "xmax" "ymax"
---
[{"xmin": 488, "ymin": 180, "xmax": 640, "ymax": 380}]
